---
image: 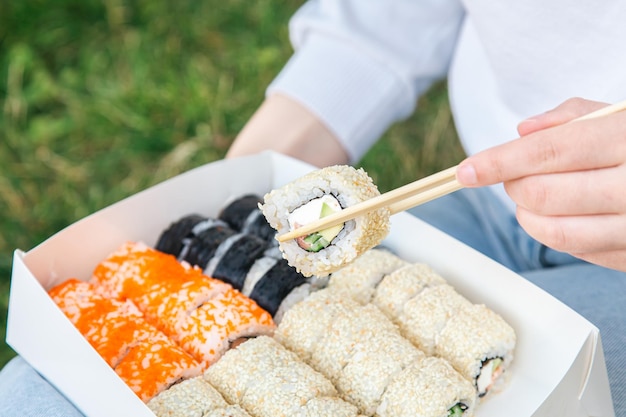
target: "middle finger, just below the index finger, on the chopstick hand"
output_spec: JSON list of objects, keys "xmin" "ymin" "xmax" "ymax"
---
[{"xmin": 504, "ymin": 165, "xmax": 626, "ymax": 216}]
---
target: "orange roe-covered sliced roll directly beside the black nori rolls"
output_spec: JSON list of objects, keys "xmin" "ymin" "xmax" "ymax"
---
[{"xmin": 91, "ymin": 242, "xmax": 275, "ymax": 368}]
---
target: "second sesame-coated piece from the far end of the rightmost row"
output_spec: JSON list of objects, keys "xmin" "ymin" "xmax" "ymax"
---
[{"xmin": 372, "ymin": 263, "xmax": 446, "ymax": 324}]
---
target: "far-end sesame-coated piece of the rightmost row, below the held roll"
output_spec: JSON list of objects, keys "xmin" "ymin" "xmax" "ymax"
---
[{"xmin": 328, "ymin": 248, "xmax": 408, "ymax": 304}]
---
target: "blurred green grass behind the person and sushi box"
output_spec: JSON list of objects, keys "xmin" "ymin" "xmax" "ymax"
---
[{"xmin": 0, "ymin": 0, "xmax": 463, "ymax": 365}]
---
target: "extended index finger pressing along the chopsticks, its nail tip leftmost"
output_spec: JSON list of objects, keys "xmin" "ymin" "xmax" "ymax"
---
[{"xmin": 457, "ymin": 112, "xmax": 626, "ymax": 187}]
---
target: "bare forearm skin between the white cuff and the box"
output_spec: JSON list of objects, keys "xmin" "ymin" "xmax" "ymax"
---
[{"xmin": 226, "ymin": 94, "xmax": 348, "ymax": 167}]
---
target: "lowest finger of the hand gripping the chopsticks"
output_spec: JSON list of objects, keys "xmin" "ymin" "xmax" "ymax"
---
[{"xmin": 516, "ymin": 207, "xmax": 626, "ymax": 253}]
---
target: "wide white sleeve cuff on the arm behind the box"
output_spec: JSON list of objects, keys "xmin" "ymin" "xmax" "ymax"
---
[{"xmin": 266, "ymin": 35, "xmax": 415, "ymax": 162}]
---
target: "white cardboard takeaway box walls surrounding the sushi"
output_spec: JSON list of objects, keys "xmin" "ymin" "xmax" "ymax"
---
[{"xmin": 7, "ymin": 152, "xmax": 614, "ymax": 417}]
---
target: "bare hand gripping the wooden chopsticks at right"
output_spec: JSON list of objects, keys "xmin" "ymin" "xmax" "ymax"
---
[{"xmin": 457, "ymin": 99, "xmax": 626, "ymax": 271}]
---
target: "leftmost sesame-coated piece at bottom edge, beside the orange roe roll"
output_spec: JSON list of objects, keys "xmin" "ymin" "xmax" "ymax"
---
[{"xmin": 148, "ymin": 376, "xmax": 249, "ymax": 417}]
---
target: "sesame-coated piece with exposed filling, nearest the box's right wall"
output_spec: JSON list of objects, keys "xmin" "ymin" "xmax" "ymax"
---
[{"xmin": 436, "ymin": 304, "xmax": 516, "ymax": 397}]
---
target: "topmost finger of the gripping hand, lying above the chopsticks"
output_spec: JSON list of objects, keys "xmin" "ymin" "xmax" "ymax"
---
[{"xmin": 517, "ymin": 98, "xmax": 607, "ymax": 136}]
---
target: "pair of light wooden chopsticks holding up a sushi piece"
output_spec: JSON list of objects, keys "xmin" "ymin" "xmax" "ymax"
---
[{"xmin": 277, "ymin": 100, "xmax": 626, "ymax": 242}]
